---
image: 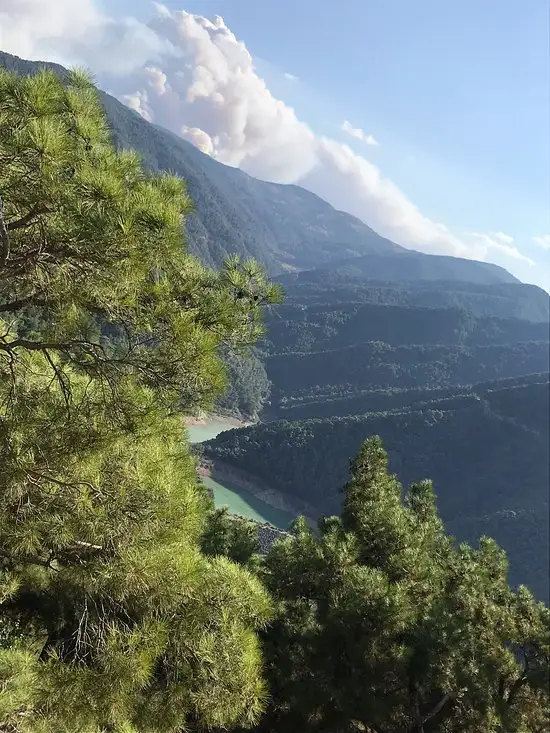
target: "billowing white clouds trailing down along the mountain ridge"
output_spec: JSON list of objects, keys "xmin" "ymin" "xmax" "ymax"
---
[{"xmin": 0, "ymin": 0, "xmax": 529, "ymax": 272}]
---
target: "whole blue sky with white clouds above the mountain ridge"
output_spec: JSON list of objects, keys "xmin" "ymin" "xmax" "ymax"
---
[{"xmin": 0, "ymin": 0, "xmax": 550, "ymax": 291}]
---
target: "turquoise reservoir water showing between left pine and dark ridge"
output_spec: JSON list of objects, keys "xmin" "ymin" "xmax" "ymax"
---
[{"xmin": 187, "ymin": 418, "xmax": 295, "ymax": 529}]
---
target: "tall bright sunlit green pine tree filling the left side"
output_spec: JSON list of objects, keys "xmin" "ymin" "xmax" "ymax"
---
[{"xmin": 0, "ymin": 71, "xmax": 278, "ymax": 733}]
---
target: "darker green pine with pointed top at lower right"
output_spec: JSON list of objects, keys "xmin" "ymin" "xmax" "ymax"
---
[{"xmin": 257, "ymin": 438, "xmax": 550, "ymax": 733}]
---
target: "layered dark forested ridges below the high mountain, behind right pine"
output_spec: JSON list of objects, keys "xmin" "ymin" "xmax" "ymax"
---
[{"xmin": 204, "ymin": 278, "xmax": 550, "ymax": 598}]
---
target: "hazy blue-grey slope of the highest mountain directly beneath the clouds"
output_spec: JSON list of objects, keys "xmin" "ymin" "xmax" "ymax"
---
[{"xmin": 0, "ymin": 52, "xmax": 528, "ymax": 284}]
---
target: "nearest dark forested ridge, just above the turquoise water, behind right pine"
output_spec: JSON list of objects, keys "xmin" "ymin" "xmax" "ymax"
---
[{"xmin": 205, "ymin": 374, "xmax": 550, "ymax": 597}]
